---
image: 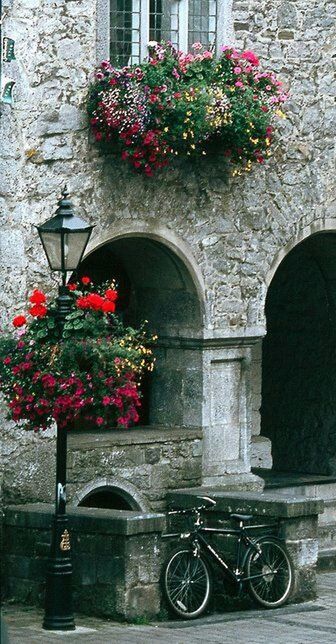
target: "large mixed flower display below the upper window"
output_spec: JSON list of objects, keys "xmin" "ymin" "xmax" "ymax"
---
[{"xmin": 88, "ymin": 43, "xmax": 287, "ymax": 176}]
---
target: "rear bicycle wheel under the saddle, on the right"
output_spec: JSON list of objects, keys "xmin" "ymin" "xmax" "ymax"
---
[{"xmin": 245, "ymin": 536, "xmax": 294, "ymax": 608}]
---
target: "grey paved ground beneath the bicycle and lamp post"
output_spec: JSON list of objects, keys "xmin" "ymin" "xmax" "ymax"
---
[{"xmin": 2, "ymin": 572, "xmax": 336, "ymax": 644}]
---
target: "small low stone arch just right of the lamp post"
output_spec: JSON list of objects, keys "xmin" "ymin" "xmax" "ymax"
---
[{"xmin": 71, "ymin": 477, "xmax": 150, "ymax": 512}]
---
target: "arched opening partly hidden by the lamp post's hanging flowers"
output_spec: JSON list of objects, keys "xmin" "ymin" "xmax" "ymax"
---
[{"xmin": 79, "ymin": 234, "xmax": 203, "ymax": 426}]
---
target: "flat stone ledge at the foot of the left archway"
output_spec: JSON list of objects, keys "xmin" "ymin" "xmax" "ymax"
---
[{"xmin": 68, "ymin": 425, "xmax": 203, "ymax": 450}]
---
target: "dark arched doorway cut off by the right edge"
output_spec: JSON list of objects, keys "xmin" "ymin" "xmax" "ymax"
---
[{"xmin": 261, "ymin": 233, "xmax": 336, "ymax": 475}]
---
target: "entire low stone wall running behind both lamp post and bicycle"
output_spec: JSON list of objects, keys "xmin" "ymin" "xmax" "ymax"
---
[{"xmin": 2, "ymin": 488, "xmax": 323, "ymax": 621}]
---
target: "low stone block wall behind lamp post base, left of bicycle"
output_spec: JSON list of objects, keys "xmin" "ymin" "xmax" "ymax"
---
[{"xmin": 2, "ymin": 504, "xmax": 165, "ymax": 621}]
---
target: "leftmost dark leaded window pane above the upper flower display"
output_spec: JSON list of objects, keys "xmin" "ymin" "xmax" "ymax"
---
[{"xmin": 110, "ymin": 0, "xmax": 140, "ymax": 67}]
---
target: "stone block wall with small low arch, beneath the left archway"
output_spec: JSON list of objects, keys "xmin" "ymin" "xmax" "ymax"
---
[{"xmin": 67, "ymin": 427, "xmax": 202, "ymax": 511}]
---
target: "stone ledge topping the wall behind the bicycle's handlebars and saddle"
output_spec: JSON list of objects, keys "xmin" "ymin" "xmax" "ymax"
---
[{"xmin": 167, "ymin": 486, "xmax": 324, "ymax": 519}]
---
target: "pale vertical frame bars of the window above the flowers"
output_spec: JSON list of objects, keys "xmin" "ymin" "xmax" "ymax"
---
[{"xmin": 96, "ymin": 0, "xmax": 234, "ymax": 63}]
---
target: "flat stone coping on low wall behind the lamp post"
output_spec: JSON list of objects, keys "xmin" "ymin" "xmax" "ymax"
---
[{"xmin": 4, "ymin": 503, "xmax": 166, "ymax": 536}]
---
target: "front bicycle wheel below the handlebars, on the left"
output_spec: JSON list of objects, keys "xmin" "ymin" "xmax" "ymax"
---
[{"xmin": 163, "ymin": 548, "xmax": 212, "ymax": 619}]
